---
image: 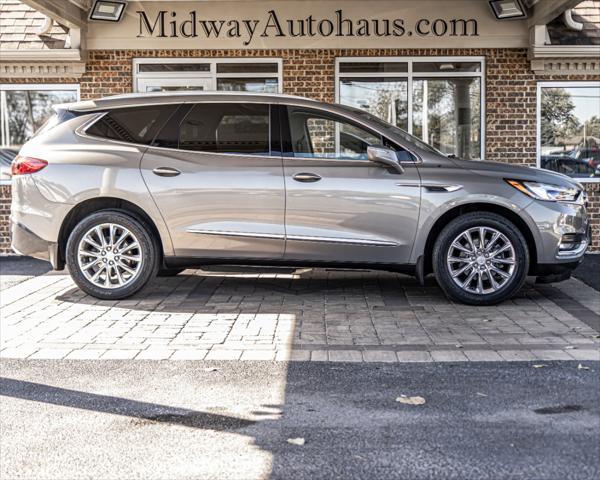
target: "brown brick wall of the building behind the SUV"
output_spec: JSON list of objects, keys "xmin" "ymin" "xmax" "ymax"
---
[{"xmin": 0, "ymin": 49, "xmax": 600, "ymax": 251}]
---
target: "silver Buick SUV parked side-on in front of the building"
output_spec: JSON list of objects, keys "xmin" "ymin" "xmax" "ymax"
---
[{"xmin": 11, "ymin": 93, "xmax": 589, "ymax": 305}]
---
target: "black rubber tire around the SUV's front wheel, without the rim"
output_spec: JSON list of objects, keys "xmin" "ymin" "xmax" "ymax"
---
[{"xmin": 433, "ymin": 212, "xmax": 529, "ymax": 305}]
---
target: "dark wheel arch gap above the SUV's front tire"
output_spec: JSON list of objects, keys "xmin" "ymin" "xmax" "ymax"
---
[{"xmin": 423, "ymin": 202, "xmax": 537, "ymax": 275}]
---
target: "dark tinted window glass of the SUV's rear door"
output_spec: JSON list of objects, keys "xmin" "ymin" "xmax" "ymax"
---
[{"xmin": 179, "ymin": 103, "xmax": 270, "ymax": 155}]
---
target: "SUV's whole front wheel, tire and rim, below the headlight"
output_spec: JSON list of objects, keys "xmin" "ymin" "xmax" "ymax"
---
[{"xmin": 433, "ymin": 212, "xmax": 529, "ymax": 305}]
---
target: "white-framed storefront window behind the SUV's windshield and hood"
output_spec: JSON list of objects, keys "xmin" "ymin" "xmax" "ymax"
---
[{"xmin": 337, "ymin": 57, "xmax": 484, "ymax": 159}]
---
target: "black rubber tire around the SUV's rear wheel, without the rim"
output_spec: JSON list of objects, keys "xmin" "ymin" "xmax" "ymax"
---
[{"xmin": 66, "ymin": 210, "xmax": 159, "ymax": 300}]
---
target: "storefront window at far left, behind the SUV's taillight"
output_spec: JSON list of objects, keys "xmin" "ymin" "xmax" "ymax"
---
[{"xmin": 0, "ymin": 85, "xmax": 79, "ymax": 149}]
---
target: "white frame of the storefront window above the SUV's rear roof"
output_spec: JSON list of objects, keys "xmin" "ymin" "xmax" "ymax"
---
[{"xmin": 133, "ymin": 57, "xmax": 283, "ymax": 93}]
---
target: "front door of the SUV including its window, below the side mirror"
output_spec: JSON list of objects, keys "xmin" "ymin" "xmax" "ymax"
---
[{"xmin": 282, "ymin": 106, "xmax": 420, "ymax": 264}]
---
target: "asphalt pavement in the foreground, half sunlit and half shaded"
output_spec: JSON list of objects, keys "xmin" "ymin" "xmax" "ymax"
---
[{"xmin": 0, "ymin": 360, "xmax": 600, "ymax": 480}]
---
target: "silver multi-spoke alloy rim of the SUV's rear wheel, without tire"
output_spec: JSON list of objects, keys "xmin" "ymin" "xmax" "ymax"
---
[{"xmin": 77, "ymin": 223, "xmax": 144, "ymax": 289}]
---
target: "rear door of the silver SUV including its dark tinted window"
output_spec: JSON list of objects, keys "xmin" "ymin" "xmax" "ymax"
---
[{"xmin": 142, "ymin": 102, "xmax": 285, "ymax": 260}]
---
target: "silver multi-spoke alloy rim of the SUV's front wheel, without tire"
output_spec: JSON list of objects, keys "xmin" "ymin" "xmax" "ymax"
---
[{"xmin": 446, "ymin": 226, "xmax": 516, "ymax": 295}]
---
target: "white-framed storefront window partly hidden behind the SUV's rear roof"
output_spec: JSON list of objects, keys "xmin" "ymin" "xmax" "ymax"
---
[{"xmin": 134, "ymin": 58, "xmax": 281, "ymax": 93}]
